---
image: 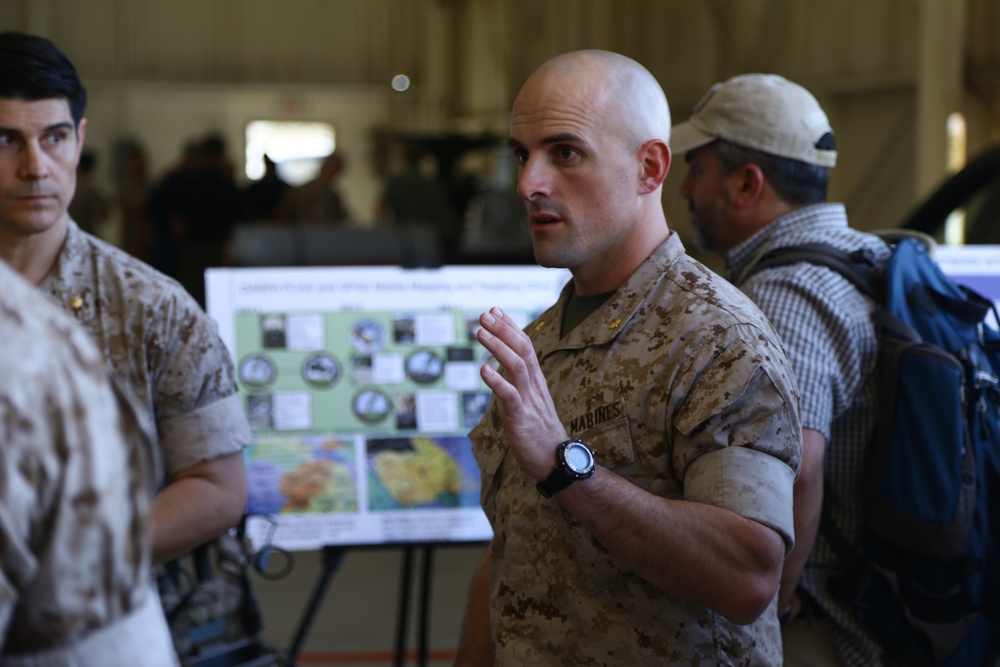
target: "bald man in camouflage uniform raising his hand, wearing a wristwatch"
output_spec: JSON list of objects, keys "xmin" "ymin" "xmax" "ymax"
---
[{"xmin": 457, "ymin": 51, "xmax": 801, "ymax": 667}]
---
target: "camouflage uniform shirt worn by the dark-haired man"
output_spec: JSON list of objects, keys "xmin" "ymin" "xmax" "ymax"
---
[{"xmin": 39, "ymin": 220, "xmax": 250, "ymax": 480}]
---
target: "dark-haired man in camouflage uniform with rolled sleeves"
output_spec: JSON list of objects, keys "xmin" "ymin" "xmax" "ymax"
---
[{"xmin": 0, "ymin": 32, "xmax": 250, "ymax": 563}]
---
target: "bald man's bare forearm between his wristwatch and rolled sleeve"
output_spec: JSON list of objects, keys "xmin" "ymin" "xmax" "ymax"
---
[{"xmin": 555, "ymin": 466, "xmax": 784, "ymax": 623}]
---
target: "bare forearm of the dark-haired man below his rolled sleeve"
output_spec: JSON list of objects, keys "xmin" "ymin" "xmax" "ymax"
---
[{"xmin": 152, "ymin": 452, "xmax": 246, "ymax": 565}]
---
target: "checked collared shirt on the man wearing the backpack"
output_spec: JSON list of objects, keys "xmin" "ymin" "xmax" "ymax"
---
[{"xmin": 726, "ymin": 204, "xmax": 889, "ymax": 667}]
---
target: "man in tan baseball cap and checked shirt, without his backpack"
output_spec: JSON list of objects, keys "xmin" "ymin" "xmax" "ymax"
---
[{"xmin": 670, "ymin": 74, "xmax": 889, "ymax": 667}]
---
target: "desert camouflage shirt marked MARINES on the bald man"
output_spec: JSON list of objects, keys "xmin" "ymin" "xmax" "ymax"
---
[{"xmin": 470, "ymin": 234, "xmax": 801, "ymax": 667}]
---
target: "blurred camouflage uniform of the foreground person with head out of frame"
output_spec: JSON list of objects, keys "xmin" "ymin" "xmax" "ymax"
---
[{"xmin": 0, "ymin": 261, "xmax": 176, "ymax": 667}]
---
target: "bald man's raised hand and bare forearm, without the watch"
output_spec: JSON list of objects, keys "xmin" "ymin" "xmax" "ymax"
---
[{"xmin": 468, "ymin": 309, "xmax": 791, "ymax": 623}]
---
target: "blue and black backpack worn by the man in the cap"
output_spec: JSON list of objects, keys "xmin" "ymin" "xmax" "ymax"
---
[{"xmin": 748, "ymin": 238, "xmax": 1000, "ymax": 667}]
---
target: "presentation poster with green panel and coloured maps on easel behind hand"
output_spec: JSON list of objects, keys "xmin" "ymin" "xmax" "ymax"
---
[{"xmin": 206, "ymin": 266, "xmax": 569, "ymax": 550}]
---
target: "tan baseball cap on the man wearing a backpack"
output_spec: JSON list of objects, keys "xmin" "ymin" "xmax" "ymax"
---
[{"xmin": 670, "ymin": 74, "xmax": 837, "ymax": 167}]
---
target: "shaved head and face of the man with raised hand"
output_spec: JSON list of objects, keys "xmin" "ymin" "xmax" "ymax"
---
[{"xmin": 507, "ymin": 51, "xmax": 670, "ymax": 295}]
